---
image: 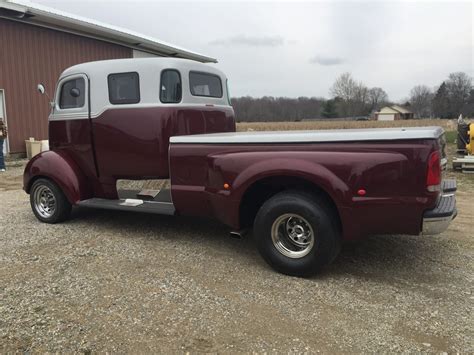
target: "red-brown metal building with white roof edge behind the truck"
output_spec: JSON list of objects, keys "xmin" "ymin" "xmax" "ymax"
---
[{"xmin": 0, "ymin": 0, "xmax": 216, "ymax": 153}]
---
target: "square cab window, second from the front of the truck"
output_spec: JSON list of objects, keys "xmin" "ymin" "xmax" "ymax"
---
[{"xmin": 107, "ymin": 72, "xmax": 140, "ymax": 105}]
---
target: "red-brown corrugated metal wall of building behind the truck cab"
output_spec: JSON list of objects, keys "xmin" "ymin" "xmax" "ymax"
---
[{"xmin": 0, "ymin": 18, "xmax": 132, "ymax": 153}]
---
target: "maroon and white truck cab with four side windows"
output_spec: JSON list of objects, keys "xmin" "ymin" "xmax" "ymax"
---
[{"xmin": 49, "ymin": 58, "xmax": 235, "ymax": 198}]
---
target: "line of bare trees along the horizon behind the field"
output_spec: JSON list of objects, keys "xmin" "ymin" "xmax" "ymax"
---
[{"xmin": 232, "ymin": 72, "xmax": 474, "ymax": 122}]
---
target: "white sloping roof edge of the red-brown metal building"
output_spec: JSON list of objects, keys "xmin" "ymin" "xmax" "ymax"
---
[{"xmin": 0, "ymin": 0, "xmax": 217, "ymax": 63}]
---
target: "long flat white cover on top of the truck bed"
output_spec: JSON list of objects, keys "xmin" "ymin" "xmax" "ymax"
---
[{"xmin": 170, "ymin": 127, "xmax": 444, "ymax": 144}]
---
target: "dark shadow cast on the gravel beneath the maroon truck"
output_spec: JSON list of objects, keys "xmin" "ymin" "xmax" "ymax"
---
[{"xmin": 68, "ymin": 208, "xmax": 456, "ymax": 282}]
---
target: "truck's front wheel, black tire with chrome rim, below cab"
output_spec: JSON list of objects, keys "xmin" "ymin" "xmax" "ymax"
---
[{"xmin": 30, "ymin": 179, "xmax": 72, "ymax": 224}]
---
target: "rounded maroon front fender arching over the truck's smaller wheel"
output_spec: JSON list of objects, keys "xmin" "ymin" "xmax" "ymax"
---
[{"xmin": 23, "ymin": 151, "xmax": 92, "ymax": 204}]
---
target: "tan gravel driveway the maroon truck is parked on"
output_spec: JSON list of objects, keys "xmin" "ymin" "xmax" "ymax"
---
[{"xmin": 0, "ymin": 166, "xmax": 474, "ymax": 353}]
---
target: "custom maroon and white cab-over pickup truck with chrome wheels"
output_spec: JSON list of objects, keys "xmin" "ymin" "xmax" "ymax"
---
[{"xmin": 24, "ymin": 58, "xmax": 456, "ymax": 275}]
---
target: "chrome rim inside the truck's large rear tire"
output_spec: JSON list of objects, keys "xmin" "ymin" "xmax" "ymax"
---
[{"xmin": 272, "ymin": 213, "xmax": 315, "ymax": 259}]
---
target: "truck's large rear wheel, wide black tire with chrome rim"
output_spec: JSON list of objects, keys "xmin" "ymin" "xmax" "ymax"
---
[{"xmin": 254, "ymin": 191, "xmax": 341, "ymax": 276}]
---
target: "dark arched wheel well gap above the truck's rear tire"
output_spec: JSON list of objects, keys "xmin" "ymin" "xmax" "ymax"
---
[{"xmin": 239, "ymin": 176, "xmax": 342, "ymax": 229}]
